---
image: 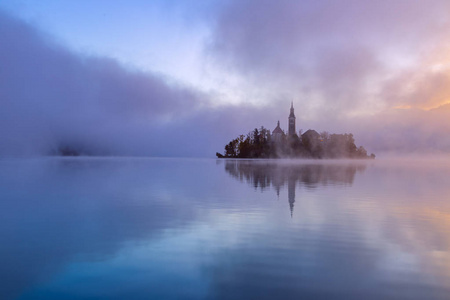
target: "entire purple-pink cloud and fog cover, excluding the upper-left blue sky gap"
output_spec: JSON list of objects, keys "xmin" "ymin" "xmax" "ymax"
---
[{"xmin": 0, "ymin": 0, "xmax": 450, "ymax": 157}]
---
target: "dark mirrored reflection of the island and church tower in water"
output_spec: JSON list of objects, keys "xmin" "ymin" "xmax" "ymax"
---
[{"xmin": 225, "ymin": 160, "xmax": 366, "ymax": 217}]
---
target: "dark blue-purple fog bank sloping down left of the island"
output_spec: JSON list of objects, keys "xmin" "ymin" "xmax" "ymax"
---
[{"xmin": 0, "ymin": 11, "xmax": 229, "ymax": 156}]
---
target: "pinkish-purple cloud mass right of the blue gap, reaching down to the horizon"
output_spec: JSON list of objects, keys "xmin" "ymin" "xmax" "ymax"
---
[{"xmin": 201, "ymin": 0, "xmax": 450, "ymax": 153}]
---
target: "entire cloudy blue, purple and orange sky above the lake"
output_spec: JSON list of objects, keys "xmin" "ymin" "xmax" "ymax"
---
[{"xmin": 0, "ymin": 0, "xmax": 450, "ymax": 157}]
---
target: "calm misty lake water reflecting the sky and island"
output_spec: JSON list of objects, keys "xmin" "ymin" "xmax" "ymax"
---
[{"xmin": 0, "ymin": 158, "xmax": 450, "ymax": 299}]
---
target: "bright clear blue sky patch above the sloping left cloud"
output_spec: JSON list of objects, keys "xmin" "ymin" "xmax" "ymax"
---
[{"xmin": 0, "ymin": 1, "xmax": 212, "ymax": 84}]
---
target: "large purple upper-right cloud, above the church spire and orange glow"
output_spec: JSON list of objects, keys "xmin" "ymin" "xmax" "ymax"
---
[{"xmin": 209, "ymin": 0, "xmax": 450, "ymax": 115}]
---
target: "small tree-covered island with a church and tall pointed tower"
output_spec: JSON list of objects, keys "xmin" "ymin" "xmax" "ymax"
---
[{"xmin": 216, "ymin": 103, "xmax": 375, "ymax": 159}]
